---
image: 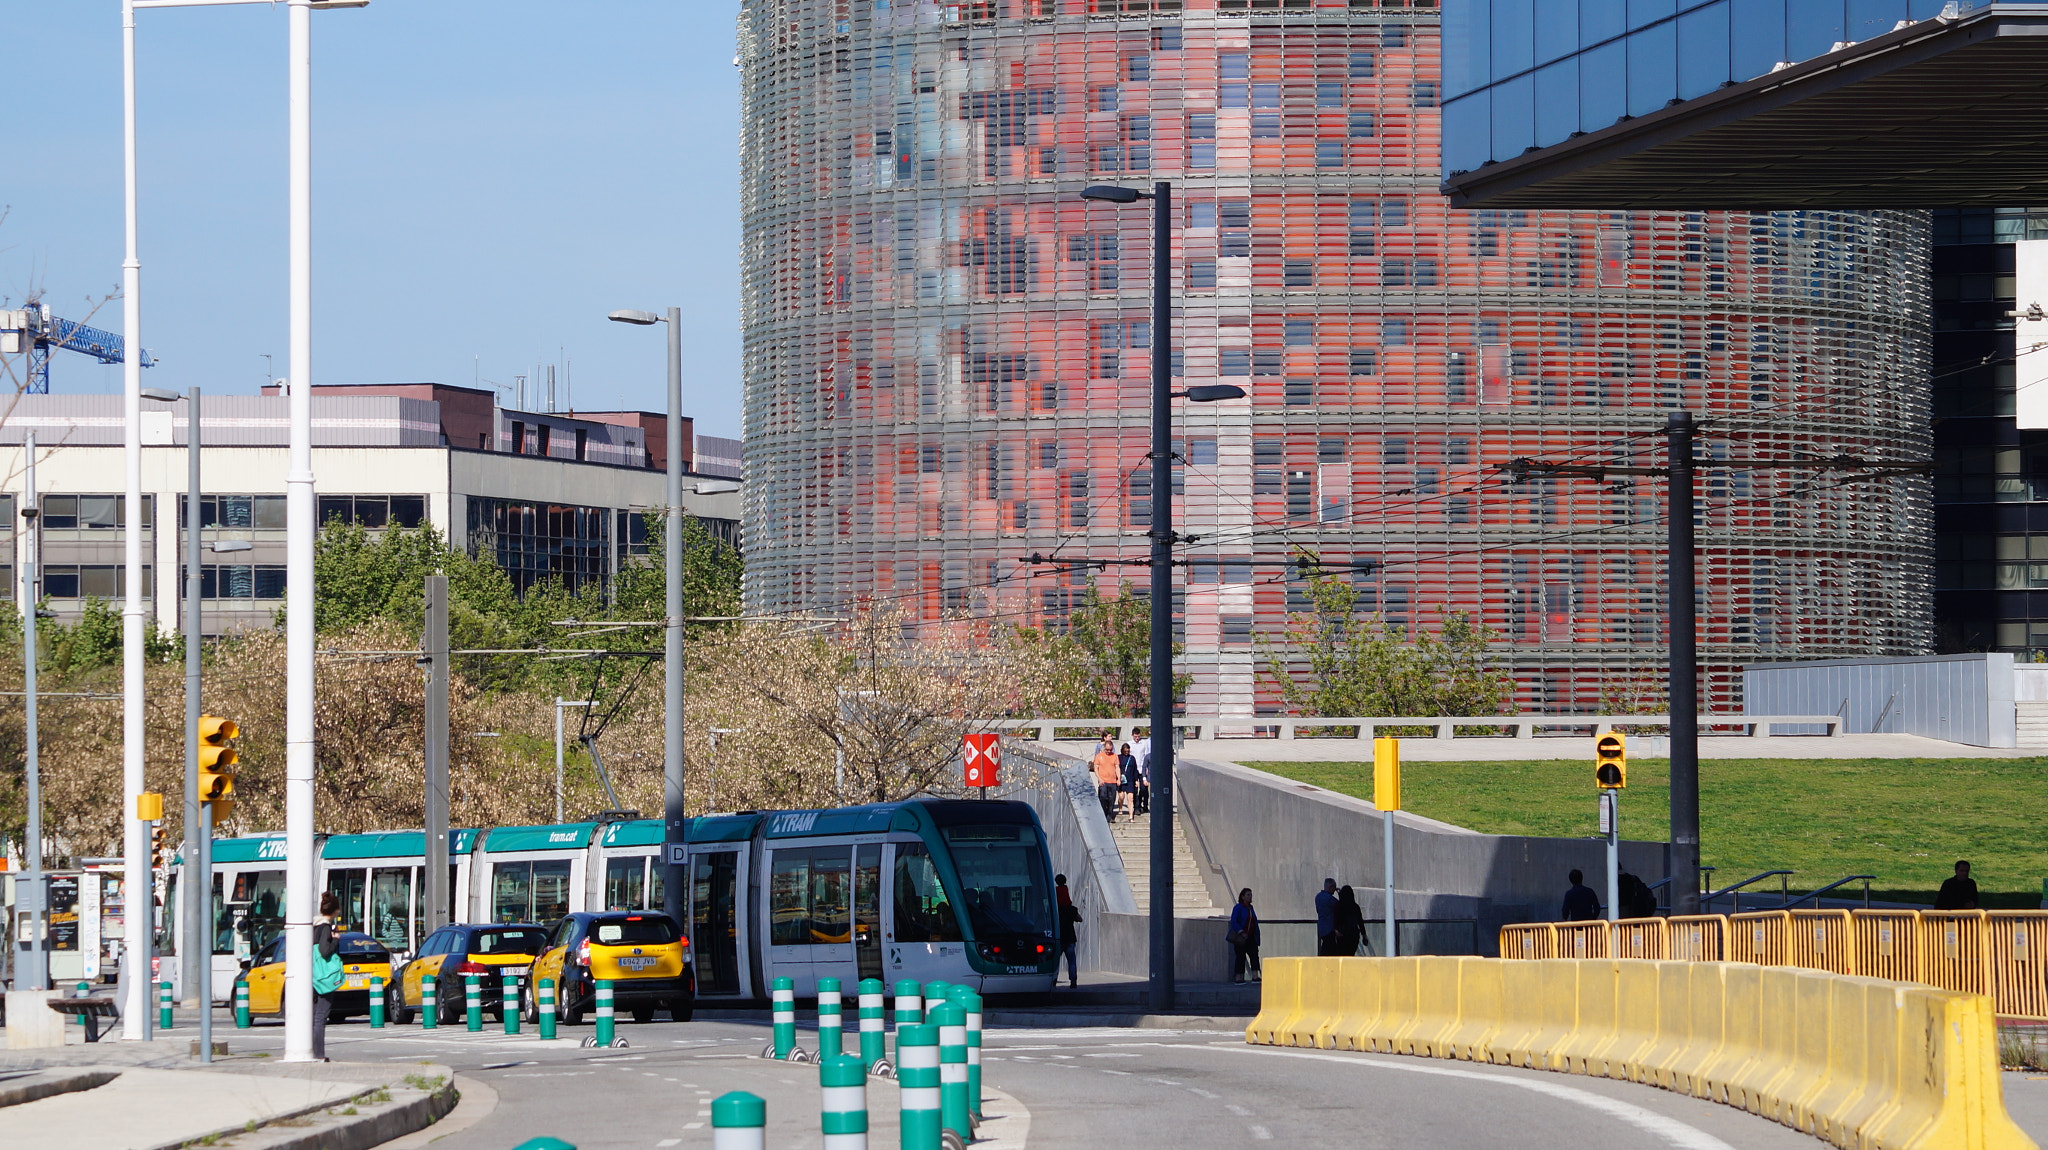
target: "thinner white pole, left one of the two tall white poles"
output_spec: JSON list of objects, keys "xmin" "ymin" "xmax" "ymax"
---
[{"xmin": 121, "ymin": 0, "xmax": 156, "ymax": 1042}]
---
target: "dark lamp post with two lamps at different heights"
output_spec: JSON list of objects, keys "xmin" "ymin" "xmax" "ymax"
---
[{"xmin": 1081, "ymin": 180, "xmax": 1245, "ymax": 1013}]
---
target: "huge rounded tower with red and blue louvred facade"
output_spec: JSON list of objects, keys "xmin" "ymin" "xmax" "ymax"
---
[{"xmin": 739, "ymin": 0, "xmax": 1931, "ymax": 716}]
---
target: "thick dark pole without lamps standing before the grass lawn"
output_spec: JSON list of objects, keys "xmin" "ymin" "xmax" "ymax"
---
[{"xmin": 1665, "ymin": 411, "xmax": 1700, "ymax": 915}]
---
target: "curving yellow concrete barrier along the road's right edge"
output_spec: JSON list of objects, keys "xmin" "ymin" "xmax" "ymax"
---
[{"xmin": 1245, "ymin": 949, "xmax": 2048, "ymax": 1150}]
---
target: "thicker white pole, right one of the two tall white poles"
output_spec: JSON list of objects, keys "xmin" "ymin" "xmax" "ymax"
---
[{"xmin": 285, "ymin": 0, "xmax": 317, "ymax": 1062}]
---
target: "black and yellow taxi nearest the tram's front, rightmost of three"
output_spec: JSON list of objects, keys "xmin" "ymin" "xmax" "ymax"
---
[{"xmin": 520, "ymin": 911, "xmax": 696, "ymax": 1025}]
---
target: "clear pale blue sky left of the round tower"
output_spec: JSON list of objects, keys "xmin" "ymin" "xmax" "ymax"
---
[{"xmin": 0, "ymin": 0, "xmax": 739, "ymax": 436}]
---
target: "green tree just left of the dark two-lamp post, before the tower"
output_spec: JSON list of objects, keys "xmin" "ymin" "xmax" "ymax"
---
[{"xmin": 1008, "ymin": 579, "xmax": 1194, "ymax": 718}]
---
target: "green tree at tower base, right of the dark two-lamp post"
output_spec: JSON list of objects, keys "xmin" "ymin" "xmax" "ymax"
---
[{"xmin": 1257, "ymin": 575, "xmax": 1513, "ymax": 716}]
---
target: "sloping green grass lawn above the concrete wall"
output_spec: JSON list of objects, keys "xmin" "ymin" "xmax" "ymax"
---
[{"xmin": 1245, "ymin": 759, "xmax": 2048, "ymax": 909}]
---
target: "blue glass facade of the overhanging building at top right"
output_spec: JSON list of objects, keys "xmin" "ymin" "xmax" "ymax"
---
[{"xmin": 1444, "ymin": 0, "xmax": 1989, "ymax": 174}]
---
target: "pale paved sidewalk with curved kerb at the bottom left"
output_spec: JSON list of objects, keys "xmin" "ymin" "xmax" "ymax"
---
[{"xmin": 0, "ymin": 1037, "xmax": 455, "ymax": 1150}]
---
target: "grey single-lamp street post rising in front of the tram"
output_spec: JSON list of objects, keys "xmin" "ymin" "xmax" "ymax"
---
[{"xmin": 610, "ymin": 307, "xmax": 690, "ymax": 923}]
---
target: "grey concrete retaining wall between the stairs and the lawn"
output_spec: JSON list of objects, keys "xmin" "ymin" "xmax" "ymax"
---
[{"xmin": 1174, "ymin": 759, "xmax": 1669, "ymax": 954}]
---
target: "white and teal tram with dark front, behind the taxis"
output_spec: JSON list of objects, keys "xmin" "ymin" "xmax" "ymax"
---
[{"xmin": 166, "ymin": 798, "xmax": 1059, "ymax": 1001}]
